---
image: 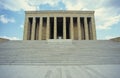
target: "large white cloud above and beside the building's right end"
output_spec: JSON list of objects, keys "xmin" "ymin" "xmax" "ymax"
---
[{"xmin": 62, "ymin": 0, "xmax": 120, "ymax": 30}]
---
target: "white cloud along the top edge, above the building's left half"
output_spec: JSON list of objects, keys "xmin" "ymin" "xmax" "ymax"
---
[{"xmin": 0, "ymin": 0, "xmax": 60, "ymax": 11}]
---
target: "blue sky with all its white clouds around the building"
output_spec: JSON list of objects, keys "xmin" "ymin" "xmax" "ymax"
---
[{"xmin": 0, "ymin": 0, "xmax": 120, "ymax": 40}]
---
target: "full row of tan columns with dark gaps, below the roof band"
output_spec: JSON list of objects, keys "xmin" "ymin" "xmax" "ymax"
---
[{"xmin": 24, "ymin": 16, "xmax": 96, "ymax": 40}]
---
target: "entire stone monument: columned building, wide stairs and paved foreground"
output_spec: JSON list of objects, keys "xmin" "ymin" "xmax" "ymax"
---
[{"xmin": 0, "ymin": 11, "xmax": 120, "ymax": 78}]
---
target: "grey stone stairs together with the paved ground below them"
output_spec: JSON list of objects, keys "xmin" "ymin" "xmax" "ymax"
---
[{"xmin": 0, "ymin": 40, "xmax": 120, "ymax": 78}]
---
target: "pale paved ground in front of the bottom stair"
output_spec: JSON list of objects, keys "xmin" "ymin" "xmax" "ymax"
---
[{"xmin": 0, "ymin": 65, "xmax": 120, "ymax": 78}]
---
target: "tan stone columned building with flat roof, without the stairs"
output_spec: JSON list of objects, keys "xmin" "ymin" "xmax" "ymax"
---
[{"xmin": 23, "ymin": 10, "xmax": 96, "ymax": 40}]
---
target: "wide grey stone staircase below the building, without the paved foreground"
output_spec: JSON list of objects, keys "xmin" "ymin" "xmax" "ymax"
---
[{"xmin": 0, "ymin": 39, "xmax": 120, "ymax": 65}]
